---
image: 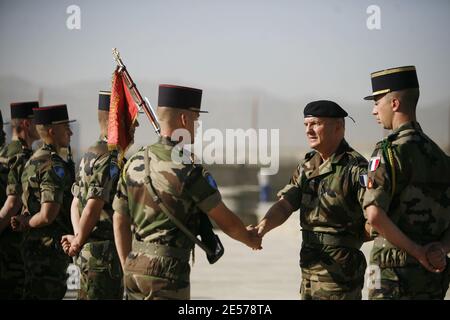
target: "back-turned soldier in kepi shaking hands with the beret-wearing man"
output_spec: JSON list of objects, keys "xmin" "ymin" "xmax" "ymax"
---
[{"xmin": 113, "ymin": 85, "xmax": 261, "ymax": 299}]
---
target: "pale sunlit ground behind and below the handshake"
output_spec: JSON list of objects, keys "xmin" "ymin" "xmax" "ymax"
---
[{"xmin": 191, "ymin": 204, "xmax": 450, "ymax": 300}]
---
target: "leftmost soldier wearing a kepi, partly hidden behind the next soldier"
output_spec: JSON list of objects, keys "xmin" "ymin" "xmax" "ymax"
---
[{"xmin": 0, "ymin": 101, "xmax": 39, "ymax": 299}]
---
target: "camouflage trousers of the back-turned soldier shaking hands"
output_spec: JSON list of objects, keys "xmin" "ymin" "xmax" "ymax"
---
[{"xmin": 124, "ymin": 252, "xmax": 190, "ymax": 300}]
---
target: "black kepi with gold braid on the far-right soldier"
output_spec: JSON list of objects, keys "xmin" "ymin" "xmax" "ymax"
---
[{"xmin": 364, "ymin": 66, "xmax": 419, "ymax": 100}]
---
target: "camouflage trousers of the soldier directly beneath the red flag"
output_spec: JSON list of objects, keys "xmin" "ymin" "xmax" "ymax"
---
[{"xmin": 75, "ymin": 240, "xmax": 123, "ymax": 300}]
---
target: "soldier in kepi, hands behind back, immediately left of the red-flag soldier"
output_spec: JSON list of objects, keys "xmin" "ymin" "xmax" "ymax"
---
[{"xmin": 11, "ymin": 105, "xmax": 74, "ymax": 299}]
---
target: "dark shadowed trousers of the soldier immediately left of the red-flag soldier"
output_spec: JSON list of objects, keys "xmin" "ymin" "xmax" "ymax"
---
[{"xmin": 22, "ymin": 236, "xmax": 70, "ymax": 300}]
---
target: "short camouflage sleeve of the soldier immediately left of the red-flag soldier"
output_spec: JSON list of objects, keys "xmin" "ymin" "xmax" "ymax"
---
[{"xmin": 39, "ymin": 161, "xmax": 64, "ymax": 204}]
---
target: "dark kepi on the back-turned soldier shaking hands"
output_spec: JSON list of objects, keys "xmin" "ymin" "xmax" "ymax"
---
[{"xmin": 158, "ymin": 84, "xmax": 208, "ymax": 113}]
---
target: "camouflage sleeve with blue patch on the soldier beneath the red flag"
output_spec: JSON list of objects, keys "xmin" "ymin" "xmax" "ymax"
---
[{"xmin": 87, "ymin": 156, "xmax": 120, "ymax": 203}]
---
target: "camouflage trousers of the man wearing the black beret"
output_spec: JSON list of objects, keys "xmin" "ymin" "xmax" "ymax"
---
[{"xmin": 300, "ymin": 243, "xmax": 367, "ymax": 300}]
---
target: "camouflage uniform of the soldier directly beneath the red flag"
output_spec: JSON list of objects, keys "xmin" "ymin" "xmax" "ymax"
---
[{"xmin": 72, "ymin": 137, "xmax": 123, "ymax": 300}]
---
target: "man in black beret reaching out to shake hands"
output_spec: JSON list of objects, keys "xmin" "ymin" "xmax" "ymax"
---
[{"xmin": 257, "ymin": 100, "xmax": 367, "ymax": 300}]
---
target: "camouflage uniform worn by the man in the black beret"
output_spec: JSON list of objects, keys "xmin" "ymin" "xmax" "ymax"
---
[{"xmin": 278, "ymin": 140, "xmax": 367, "ymax": 299}]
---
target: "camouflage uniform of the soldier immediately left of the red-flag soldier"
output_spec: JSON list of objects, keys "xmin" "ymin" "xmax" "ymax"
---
[{"xmin": 22, "ymin": 144, "xmax": 74, "ymax": 299}]
